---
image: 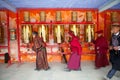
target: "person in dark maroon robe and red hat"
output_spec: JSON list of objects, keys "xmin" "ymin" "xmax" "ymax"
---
[{"xmin": 95, "ymin": 30, "xmax": 109, "ymax": 69}]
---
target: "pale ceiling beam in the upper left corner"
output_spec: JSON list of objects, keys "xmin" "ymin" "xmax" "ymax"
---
[{"xmin": 0, "ymin": 0, "xmax": 16, "ymax": 12}]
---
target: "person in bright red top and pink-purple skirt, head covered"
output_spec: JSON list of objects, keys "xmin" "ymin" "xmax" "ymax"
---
[{"xmin": 67, "ymin": 31, "xmax": 82, "ymax": 71}]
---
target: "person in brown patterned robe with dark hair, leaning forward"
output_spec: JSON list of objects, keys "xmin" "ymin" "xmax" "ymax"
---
[{"xmin": 32, "ymin": 32, "xmax": 49, "ymax": 70}]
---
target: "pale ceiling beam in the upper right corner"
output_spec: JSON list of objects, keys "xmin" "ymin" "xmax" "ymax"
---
[{"xmin": 99, "ymin": 0, "xmax": 120, "ymax": 12}]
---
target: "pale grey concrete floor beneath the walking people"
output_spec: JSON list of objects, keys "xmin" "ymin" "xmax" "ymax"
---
[{"xmin": 0, "ymin": 61, "xmax": 120, "ymax": 80}]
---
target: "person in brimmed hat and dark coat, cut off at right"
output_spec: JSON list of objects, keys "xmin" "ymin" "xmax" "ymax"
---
[{"xmin": 105, "ymin": 23, "xmax": 120, "ymax": 80}]
